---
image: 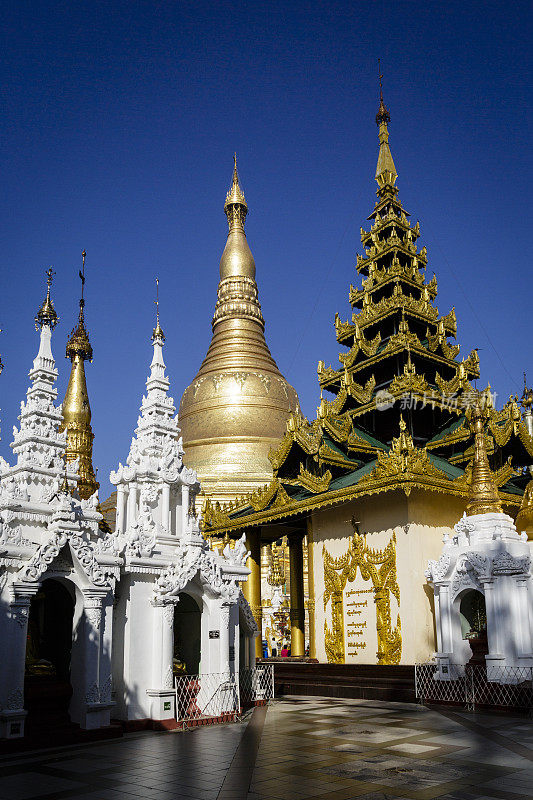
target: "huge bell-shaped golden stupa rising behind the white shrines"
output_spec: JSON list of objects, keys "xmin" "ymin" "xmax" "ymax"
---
[{"xmin": 178, "ymin": 159, "xmax": 298, "ymax": 501}]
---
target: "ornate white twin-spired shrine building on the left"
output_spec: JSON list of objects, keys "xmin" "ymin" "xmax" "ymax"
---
[{"xmin": 0, "ymin": 278, "xmax": 257, "ymax": 738}]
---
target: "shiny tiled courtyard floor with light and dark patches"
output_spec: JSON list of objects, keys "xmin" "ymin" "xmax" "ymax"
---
[{"xmin": 0, "ymin": 697, "xmax": 533, "ymax": 800}]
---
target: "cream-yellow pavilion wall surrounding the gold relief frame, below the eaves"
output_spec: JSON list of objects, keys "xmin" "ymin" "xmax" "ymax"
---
[{"xmin": 312, "ymin": 491, "xmax": 464, "ymax": 664}]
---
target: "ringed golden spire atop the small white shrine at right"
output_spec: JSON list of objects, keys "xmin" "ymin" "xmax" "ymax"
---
[{"xmin": 466, "ymin": 394, "xmax": 502, "ymax": 517}]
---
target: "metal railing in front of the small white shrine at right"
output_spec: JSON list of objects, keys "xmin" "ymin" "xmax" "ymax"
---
[{"xmin": 415, "ymin": 662, "xmax": 533, "ymax": 713}]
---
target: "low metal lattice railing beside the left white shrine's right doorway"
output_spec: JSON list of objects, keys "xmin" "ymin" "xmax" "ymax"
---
[{"xmin": 174, "ymin": 664, "xmax": 274, "ymax": 725}]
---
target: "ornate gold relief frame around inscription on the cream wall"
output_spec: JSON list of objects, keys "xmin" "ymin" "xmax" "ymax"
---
[{"xmin": 322, "ymin": 532, "xmax": 402, "ymax": 664}]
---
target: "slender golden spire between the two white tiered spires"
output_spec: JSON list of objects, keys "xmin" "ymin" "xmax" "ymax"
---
[{"xmin": 62, "ymin": 250, "xmax": 98, "ymax": 499}]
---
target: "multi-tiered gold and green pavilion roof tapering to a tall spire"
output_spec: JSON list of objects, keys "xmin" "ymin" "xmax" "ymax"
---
[{"xmin": 205, "ymin": 95, "xmax": 533, "ymax": 533}]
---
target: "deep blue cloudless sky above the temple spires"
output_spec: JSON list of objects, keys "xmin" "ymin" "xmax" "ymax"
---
[{"xmin": 0, "ymin": 0, "xmax": 533, "ymax": 497}]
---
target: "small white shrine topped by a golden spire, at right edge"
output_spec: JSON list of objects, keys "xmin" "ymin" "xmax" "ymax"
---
[{"xmin": 426, "ymin": 406, "xmax": 533, "ymax": 683}]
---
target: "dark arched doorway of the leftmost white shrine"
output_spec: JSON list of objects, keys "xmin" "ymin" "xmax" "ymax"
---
[{"xmin": 24, "ymin": 579, "xmax": 74, "ymax": 736}]
